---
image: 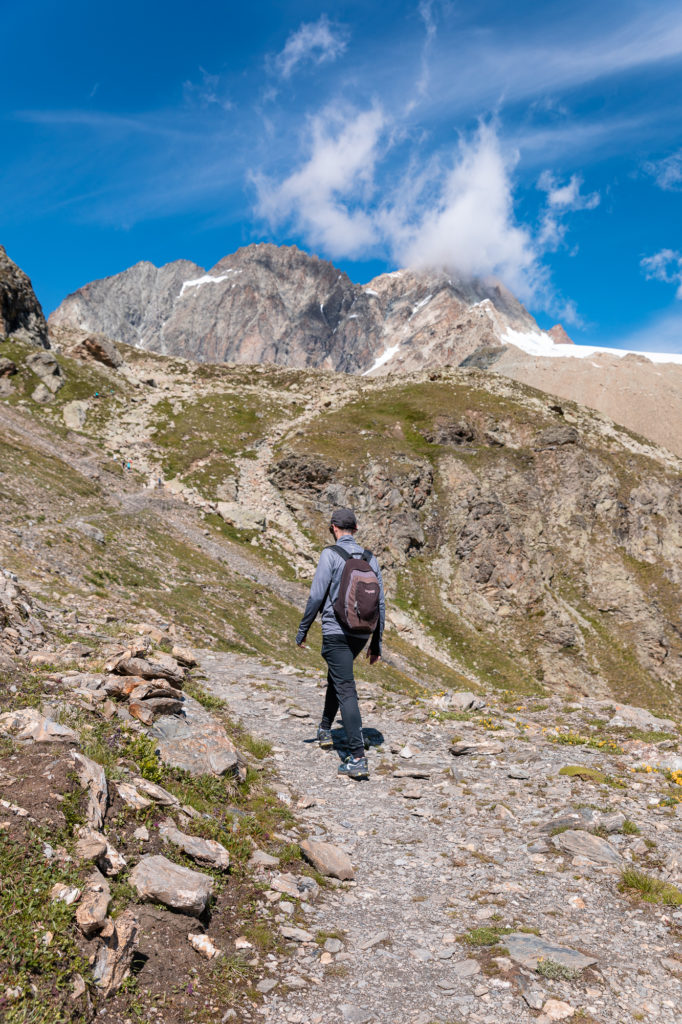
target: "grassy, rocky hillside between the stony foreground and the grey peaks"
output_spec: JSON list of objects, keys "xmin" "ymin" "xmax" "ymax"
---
[{"xmin": 3, "ymin": 329, "xmax": 682, "ymax": 710}]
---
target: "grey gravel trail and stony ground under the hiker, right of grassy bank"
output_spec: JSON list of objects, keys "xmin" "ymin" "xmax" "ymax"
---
[{"xmin": 191, "ymin": 651, "xmax": 682, "ymax": 1024}]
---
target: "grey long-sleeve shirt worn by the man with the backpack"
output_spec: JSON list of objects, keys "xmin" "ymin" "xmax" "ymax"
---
[{"xmin": 296, "ymin": 535, "xmax": 386, "ymax": 654}]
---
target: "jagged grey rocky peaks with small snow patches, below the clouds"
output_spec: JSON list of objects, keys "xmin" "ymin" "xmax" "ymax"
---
[{"xmin": 50, "ymin": 244, "xmax": 539, "ymax": 373}]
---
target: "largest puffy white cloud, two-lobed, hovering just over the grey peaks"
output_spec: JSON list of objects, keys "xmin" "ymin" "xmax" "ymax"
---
[{"xmin": 254, "ymin": 108, "xmax": 561, "ymax": 305}]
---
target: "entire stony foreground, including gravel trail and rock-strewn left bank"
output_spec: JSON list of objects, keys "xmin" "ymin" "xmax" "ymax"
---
[{"xmin": 0, "ymin": 572, "xmax": 682, "ymax": 1024}]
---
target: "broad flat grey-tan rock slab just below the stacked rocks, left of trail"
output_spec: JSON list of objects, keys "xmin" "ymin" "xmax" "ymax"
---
[{"xmin": 150, "ymin": 696, "xmax": 243, "ymax": 778}]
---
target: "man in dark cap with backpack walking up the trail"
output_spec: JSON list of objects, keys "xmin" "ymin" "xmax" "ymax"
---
[{"xmin": 296, "ymin": 508, "xmax": 385, "ymax": 778}]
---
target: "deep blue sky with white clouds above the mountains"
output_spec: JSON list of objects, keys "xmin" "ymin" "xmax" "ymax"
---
[{"xmin": 0, "ymin": 0, "xmax": 682, "ymax": 352}]
